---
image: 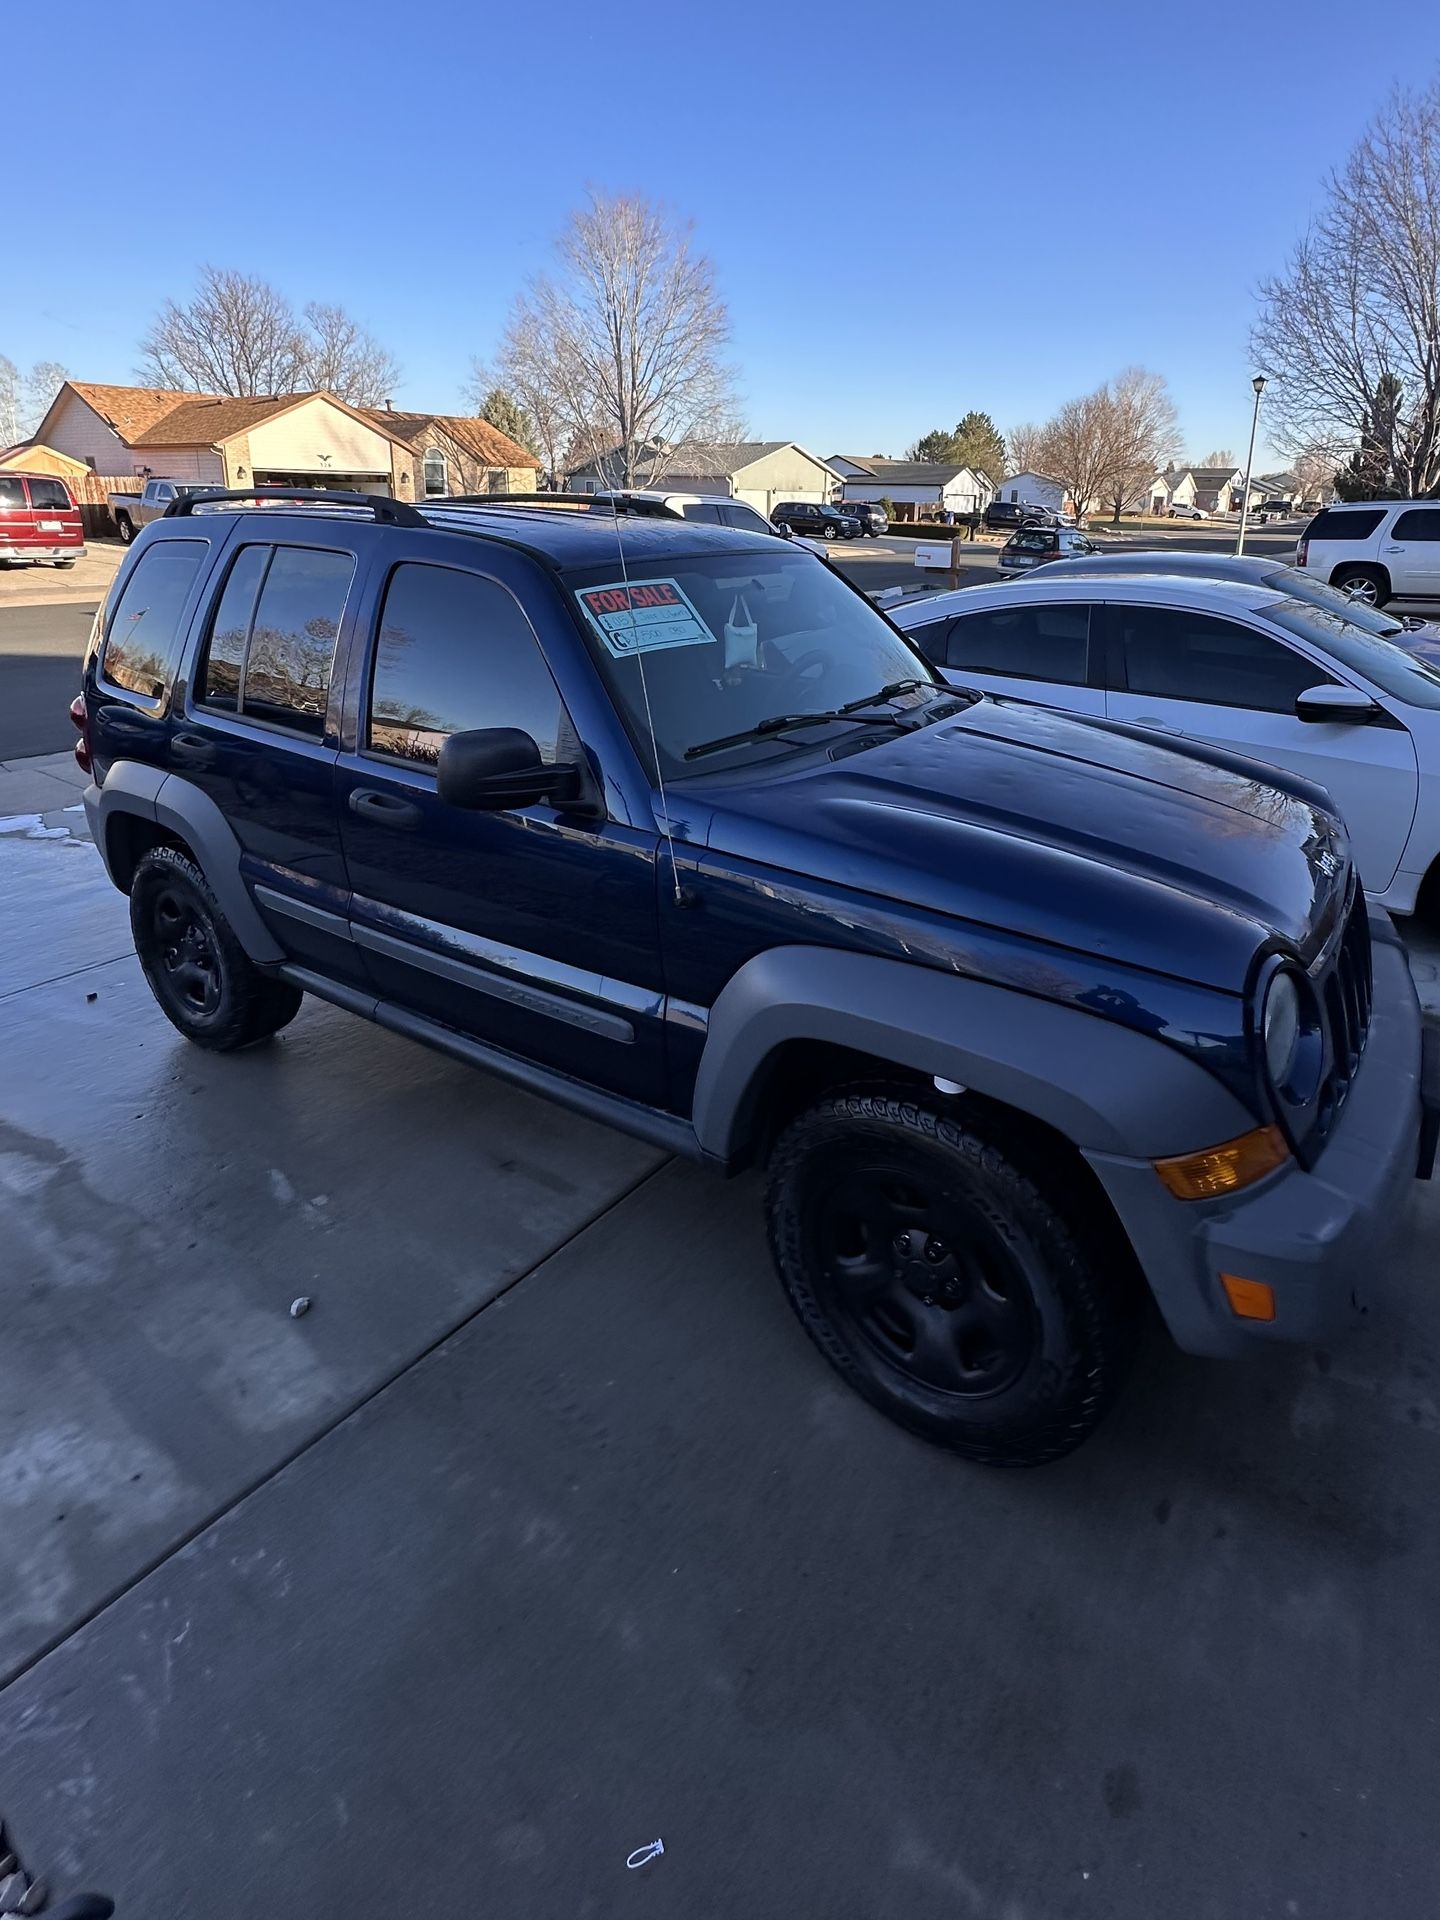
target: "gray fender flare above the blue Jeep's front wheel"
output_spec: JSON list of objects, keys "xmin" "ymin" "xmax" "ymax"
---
[{"xmin": 693, "ymin": 947, "xmax": 1256, "ymax": 1162}]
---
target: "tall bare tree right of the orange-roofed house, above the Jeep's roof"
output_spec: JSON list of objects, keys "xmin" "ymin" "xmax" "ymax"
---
[{"xmin": 499, "ymin": 192, "xmax": 733, "ymax": 486}]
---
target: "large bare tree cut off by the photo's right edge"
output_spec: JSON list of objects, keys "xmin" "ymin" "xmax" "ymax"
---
[{"xmin": 1252, "ymin": 79, "xmax": 1440, "ymax": 495}]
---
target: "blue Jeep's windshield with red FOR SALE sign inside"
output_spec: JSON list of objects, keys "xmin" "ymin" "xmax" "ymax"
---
[{"xmin": 566, "ymin": 541, "xmax": 941, "ymax": 780}]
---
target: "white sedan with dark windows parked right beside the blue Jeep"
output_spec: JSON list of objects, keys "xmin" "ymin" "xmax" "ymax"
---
[{"xmin": 891, "ymin": 568, "xmax": 1440, "ymax": 914}]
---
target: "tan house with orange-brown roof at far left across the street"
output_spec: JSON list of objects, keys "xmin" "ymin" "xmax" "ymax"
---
[{"xmin": 35, "ymin": 380, "xmax": 538, "ymax": 499}]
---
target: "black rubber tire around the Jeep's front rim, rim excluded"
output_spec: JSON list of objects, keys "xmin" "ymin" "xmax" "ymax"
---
[{"xmin": 766, "ymin": 1089, "xmax": 1139, "ymax": 1467}]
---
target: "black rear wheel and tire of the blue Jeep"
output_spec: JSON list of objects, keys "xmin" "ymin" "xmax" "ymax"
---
[{"xmin": 131, "ymin": 847, "xmax": 303, "ymax": 1054}]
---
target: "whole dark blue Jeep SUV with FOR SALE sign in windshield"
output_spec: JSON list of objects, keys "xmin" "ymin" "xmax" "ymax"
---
[{"xmin": 81, "ymin": 493, "xmax": 1440, "ymax": 1465}]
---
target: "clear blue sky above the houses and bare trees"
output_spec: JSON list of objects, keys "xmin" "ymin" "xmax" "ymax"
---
[{"xmin": 11, "ymin": 0, "xmax": 1440, "ymax": 459}]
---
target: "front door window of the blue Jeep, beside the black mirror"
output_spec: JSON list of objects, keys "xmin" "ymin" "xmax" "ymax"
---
[{"xmin": 365, "ymin": 563, "xmax": 574, "ymax": 768}]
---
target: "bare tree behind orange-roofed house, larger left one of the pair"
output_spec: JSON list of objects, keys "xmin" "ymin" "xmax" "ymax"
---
[{"xmin": 140, "ymin": 267, "xmax": 307, "ymax": 394}]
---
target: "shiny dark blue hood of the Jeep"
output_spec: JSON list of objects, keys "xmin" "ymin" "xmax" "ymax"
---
[{"xmin": 684, "ymin": 699, "xmax": 1350, "ymax": 993}]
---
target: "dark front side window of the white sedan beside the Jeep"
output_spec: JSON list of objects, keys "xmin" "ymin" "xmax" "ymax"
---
[{"xmin": 1110, "ymin": 607, "xmax": 1334, "ymax": 714}]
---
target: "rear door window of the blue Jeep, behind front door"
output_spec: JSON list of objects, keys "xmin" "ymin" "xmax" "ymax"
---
[{"xmin": 196, "ymin": 545, "xmax": 355, "ymax": 739}]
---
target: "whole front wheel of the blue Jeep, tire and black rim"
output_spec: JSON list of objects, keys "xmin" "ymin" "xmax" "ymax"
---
[{"xmin": 766, "ymin": 1089, "xmax": 1135, "ymax": 1467}]
